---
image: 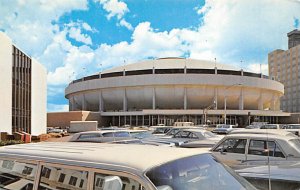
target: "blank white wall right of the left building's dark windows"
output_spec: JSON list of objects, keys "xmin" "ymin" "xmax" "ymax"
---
[{"xmin": 31, "ymin": 59, "xmax": 47, "ymax": 135}]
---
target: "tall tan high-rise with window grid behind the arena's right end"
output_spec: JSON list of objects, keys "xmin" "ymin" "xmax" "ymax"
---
[{"xmin": 268, "ymin": 30, "xmax": 300, "ymax": 112}]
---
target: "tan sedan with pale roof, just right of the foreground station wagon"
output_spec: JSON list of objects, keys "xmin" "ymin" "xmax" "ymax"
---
[{"xmin": 211, "ymin": 133, "xmax": 300, "ymax": 167}]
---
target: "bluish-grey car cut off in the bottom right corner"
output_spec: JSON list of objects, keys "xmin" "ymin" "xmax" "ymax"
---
[{"xmin": 236, "ymin": 162, "xmax": 300, "ymax": 190}]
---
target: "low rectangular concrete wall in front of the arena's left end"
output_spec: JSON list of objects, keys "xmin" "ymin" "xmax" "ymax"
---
[{"xmin": 69, "ymin": 121, "xmax": 98, "ymax": 133}]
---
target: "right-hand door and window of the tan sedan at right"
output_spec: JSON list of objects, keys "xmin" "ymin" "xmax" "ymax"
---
[{"xmin": 247, "ymin": 139, "xmax": 286, "ymax": 165}]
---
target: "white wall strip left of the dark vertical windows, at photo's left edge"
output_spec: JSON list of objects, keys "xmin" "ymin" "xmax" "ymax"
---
[{"xmin": 0, "ymin": 32, "xmax": 12, "ymax": 134}]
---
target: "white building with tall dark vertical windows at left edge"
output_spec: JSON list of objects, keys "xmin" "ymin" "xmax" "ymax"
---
[{"xmin": 0, "ymin": 32, "xmax": 47, "ymax": 135}]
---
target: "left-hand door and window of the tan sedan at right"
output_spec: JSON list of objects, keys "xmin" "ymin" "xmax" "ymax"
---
[{"xmin": 212, "ymin": 138, "xmax": 247, "ymax": 167}]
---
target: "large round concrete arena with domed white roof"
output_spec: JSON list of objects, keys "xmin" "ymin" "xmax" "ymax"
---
[{"xmin": 65, "ymin": 58, "xmax": 289, "ymax": 126}]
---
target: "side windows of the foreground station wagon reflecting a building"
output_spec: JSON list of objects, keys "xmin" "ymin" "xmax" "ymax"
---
[{"xmin": 0, "ymin": 160, "xmax": 143, "ymax": 190}]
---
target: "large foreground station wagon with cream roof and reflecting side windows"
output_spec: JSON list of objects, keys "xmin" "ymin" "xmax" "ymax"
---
[{"xmin": 0, "ymin": 142, "xmax": 256, "ymax": 190}]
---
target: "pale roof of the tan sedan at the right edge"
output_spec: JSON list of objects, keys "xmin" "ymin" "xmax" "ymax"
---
[{"xmin": 224, "ymin": 133, "xmax": 298, "ymax": 140}]
